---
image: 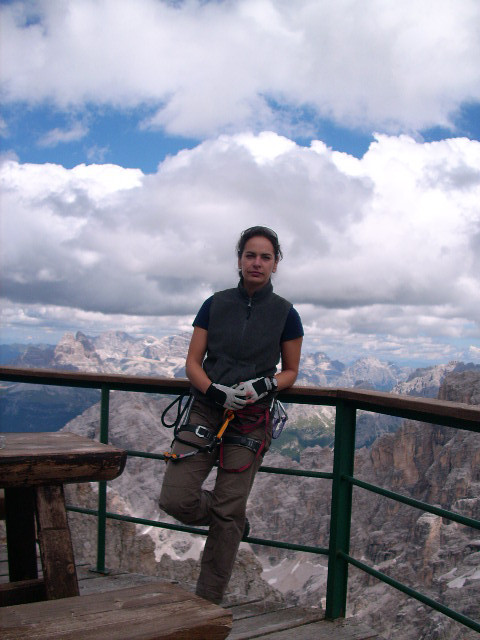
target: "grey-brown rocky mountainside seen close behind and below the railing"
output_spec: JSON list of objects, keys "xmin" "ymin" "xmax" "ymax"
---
[{"xmin": 64, "ymin": 371, "xmax": 480, "ymax": 640}]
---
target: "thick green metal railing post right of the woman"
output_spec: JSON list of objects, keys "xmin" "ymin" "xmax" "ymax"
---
[{"xmin": 325, "ymin": 400, "xmax": 356, "ymax": 619}]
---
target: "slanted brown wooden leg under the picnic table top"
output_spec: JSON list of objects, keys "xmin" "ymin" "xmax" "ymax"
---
[{"xmin": 36, "ymin": 485, "xmax": 79, "ymax": 599}]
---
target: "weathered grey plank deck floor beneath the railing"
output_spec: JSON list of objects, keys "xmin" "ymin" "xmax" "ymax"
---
[{"xmin": 0, "ymin": 545, "xmax": 382, "ymax": 640}]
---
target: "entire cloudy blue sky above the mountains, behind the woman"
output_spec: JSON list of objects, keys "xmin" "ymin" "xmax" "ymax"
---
[{"xmin": 0, "ymin": 0, "xmax": 480, "ymax": 366}]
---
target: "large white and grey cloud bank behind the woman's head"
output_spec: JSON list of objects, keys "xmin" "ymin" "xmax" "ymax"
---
[{"xmin": 0, "ymin": 133, "xmax": 480, "ymax": 360}]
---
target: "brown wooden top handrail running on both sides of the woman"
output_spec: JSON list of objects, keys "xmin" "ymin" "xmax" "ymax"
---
[{"xmin": 0, "ymin": 366, "xmax": 480, "ymax": 432}]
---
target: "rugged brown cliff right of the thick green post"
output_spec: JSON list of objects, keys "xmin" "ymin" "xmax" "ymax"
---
[{"xmin": 350, "ymin": 422, "xmax": 480, "ymax": 640}]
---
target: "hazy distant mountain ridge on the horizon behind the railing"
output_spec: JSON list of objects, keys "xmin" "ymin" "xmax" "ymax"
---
[{"xmin": 0, "ymin": 331, "xmax": 473, "ymax": 444}]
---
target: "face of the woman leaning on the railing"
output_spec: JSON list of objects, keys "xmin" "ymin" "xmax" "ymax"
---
[{"xmin": 238, "ymin": 236, "xmax": 278, "ymax": 295}]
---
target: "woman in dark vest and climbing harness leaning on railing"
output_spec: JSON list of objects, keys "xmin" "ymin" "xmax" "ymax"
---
[{"xmin": 159, "ymin": 226, "xmax": 303, "ymax": 604}]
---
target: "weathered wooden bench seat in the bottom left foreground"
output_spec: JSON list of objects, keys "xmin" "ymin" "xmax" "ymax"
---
[{"xmin": 0, "ymin": 582, "xmax": 232, "ymax": 640}]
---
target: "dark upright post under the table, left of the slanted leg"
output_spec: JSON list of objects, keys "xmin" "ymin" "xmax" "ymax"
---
[{"xmin": 5, "ymin": 487, "xmax": 38, "ymax": 582}]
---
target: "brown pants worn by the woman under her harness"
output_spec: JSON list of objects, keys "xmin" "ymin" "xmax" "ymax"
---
[{"xmin": 159, "ymin": 400, "xmax": 271, "ymax": 604}]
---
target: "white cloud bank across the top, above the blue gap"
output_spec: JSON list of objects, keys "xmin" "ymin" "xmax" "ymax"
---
[{"xmin": 0, "ymin": 0, "xmax": 480, "ymax": 136}]
